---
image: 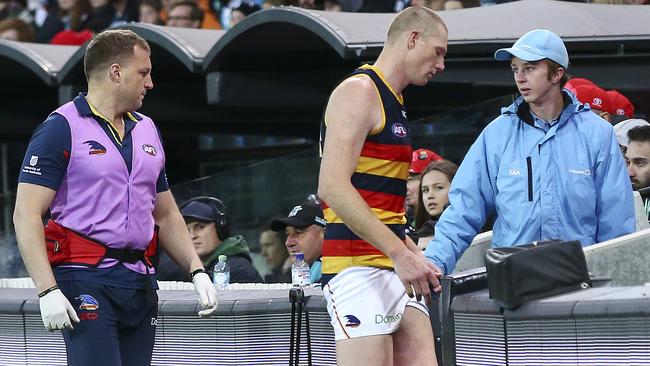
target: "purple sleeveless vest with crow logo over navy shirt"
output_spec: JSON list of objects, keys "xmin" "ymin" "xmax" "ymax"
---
[{"xmin": 51, "ymin": 102, "xmax": 165, "ymax": 273}]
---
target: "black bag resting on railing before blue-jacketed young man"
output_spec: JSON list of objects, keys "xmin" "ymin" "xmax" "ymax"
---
[{"xmin": 485, "ymin": 240, "xmax": 591, "ymax": 309}]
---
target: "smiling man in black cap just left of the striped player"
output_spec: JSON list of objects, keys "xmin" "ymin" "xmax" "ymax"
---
[{"xmin": 271, "ymin": 203, "xmax": 327, "ymax": 283}]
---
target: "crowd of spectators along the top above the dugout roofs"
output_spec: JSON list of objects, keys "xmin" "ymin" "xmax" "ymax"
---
[{"xmin": 0, "ymin": 0, "xmax": 648, "ymax": 45}]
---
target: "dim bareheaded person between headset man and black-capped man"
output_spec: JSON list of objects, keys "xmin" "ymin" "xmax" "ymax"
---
[{"xmin": 260, "ymin": 230, "xmax": 291, "ymax": 283}]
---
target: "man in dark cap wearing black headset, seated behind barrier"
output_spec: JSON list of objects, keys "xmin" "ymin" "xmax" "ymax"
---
[{"xmin": 176, "ymin": 197, "xmax": 264, "ymax": 283}]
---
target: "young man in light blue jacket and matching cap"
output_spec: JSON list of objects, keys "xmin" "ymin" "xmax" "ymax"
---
[{"xmin": 425, "ymin": 29, "xmax": 635, "ymax": 274}]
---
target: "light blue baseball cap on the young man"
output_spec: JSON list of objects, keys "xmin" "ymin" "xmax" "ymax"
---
[{"xmin": 494, "ymin": 29, "xmax": 569, "ymax": 69}]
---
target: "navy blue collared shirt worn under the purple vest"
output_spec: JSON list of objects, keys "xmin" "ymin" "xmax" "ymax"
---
[{"xmin": 18, "ymin": 94, "xmax": 169, "ymax": 288}]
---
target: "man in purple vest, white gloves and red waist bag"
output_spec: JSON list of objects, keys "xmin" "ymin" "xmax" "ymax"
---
[{"xmin": 14, "ymin": 30, "xmax": 217, "ymax": 365}]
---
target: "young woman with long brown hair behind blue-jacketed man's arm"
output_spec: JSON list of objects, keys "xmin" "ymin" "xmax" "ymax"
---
[{"xmin": 411, "ymin": 160, "xmax": 458, "ymax": 249}]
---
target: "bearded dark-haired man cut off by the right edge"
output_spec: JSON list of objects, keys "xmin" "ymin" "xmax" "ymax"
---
[{"xmin": 625, "ymin": 125, "xmax": 650, "ymax": 221}]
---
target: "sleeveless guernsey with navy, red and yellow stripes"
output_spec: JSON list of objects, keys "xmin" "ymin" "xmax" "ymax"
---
[{"xmin": 321, "ymin": 65, "xmax": 412, "ymax": 284}]
